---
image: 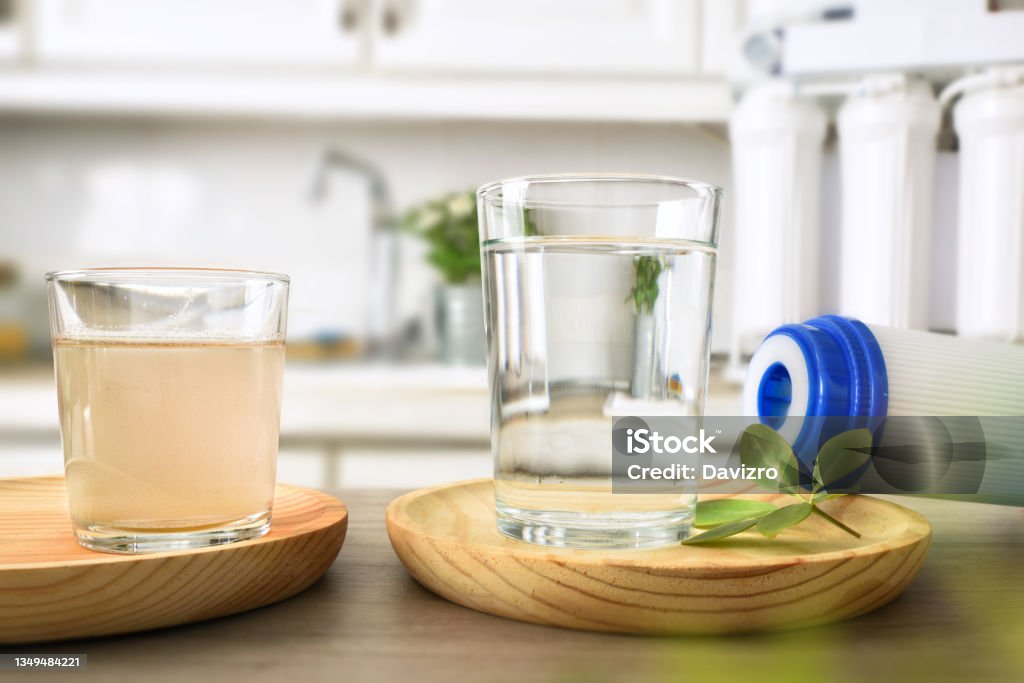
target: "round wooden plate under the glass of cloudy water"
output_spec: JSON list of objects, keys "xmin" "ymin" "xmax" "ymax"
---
[{"xmin": 0, "ymin": 477, "xmax": 348, "ymax": 644}]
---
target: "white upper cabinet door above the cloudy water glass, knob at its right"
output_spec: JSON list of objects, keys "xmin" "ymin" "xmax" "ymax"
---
[{"xmin": 30, "ymin": 0, "xmax": 370, "ymax": 68}]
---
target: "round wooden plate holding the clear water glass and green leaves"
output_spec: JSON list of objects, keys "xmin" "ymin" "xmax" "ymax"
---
[{"xmin": 387, "ymin": 479, "xmax": 932, "ymax": 634}]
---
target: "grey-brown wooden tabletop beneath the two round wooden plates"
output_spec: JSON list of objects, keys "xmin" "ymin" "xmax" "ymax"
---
[{"xmin": 4, "ymin": 490, "xmax": 1024, "ymax": 683}]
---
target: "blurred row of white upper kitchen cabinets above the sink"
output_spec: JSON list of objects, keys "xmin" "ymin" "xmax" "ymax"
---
[{"xmin": 0, "ymin": 0, "xmax": 745, "ymax": 123}]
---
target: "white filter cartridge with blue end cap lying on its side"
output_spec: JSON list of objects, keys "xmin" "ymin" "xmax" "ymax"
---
[{"xmin": 742, "ymin": 315, "xmax": 1024, "ymax": 504}]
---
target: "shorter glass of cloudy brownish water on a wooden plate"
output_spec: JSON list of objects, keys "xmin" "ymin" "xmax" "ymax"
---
[{"xmin": 46, "ymin": 268, "xmax": 289, "ymax": 553}]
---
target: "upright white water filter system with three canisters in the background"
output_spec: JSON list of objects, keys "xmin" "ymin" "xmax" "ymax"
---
[{"xmin": 726, "ymin": 0, "xmax": 1024, "ymax": 378}]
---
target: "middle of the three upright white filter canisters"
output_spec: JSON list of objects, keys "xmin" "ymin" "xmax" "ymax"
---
[{"xmin": 838, "ymin": 77, "xmax": 941, "ymax": 329}]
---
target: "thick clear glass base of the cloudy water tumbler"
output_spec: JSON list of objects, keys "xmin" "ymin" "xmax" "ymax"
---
[{"xmin": 75, "ymin": 510, "xmax": 270, "ymax": 555}]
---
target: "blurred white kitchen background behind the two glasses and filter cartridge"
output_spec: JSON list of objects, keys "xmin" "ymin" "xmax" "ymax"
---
[{"xmin": 0, "ymin": 0, "xmax": 1024, "ymax": 487}]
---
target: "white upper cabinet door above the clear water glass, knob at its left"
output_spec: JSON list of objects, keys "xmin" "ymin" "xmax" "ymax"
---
[{"xmin": 372, "ymin": 0, "xmax": 700, "ymax": 76}]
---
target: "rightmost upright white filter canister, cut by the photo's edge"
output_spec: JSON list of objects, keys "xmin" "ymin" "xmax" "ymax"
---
[{"xmin": 953, "ymin": 67, "xmax": 1024, "ymax": 341}]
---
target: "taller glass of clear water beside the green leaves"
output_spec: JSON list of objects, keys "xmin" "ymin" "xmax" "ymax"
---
[{"xmin": 477, "ymin": 175, "xmax": 722, "ymax": 548}]
